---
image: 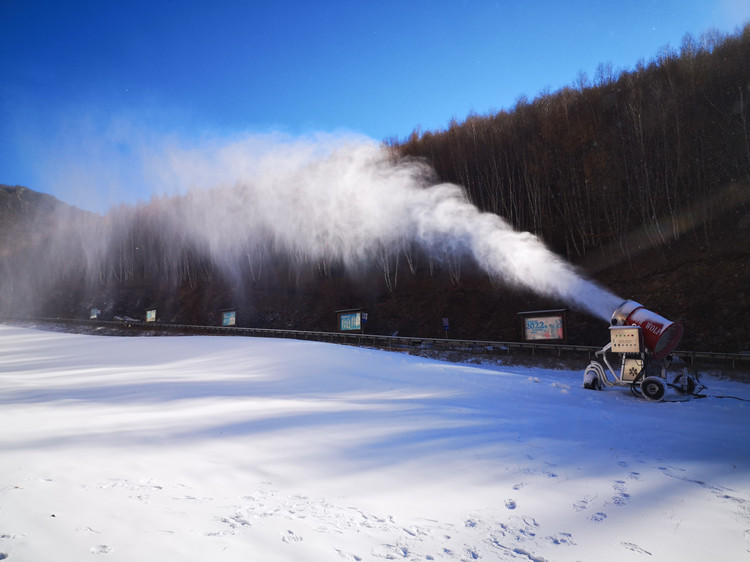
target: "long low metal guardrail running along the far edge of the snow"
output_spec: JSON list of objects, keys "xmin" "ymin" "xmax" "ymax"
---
[{"xmin": 0, "ymin": 317, "xmax": 750, "ymax": 367}]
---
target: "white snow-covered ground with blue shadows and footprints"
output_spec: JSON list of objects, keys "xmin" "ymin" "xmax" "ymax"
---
[{"xmin": 0, "ymin": 325, "xmax": 750, "ymax": 562}]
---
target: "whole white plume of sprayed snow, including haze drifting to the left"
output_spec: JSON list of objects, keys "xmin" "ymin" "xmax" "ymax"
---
[{"xmin": 0, "ymin": 131, "xmax": 622, "ymax": 320}]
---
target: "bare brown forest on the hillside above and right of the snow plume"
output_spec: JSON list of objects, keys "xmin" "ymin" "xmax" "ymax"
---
[{"xmin": 390, "ymin": 25, "xmax": 750, "ymax": 260}]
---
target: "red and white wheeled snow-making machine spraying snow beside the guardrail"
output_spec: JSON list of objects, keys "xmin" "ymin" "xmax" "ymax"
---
[{"xmin": 583, "ymin": 301, "xmax": 698, "ymax": 402}]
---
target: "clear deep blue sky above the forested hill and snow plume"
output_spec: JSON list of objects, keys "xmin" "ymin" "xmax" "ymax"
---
[{"xmin": 0, "ymin": 0, "xmax": 750, "ymax": 209}]
